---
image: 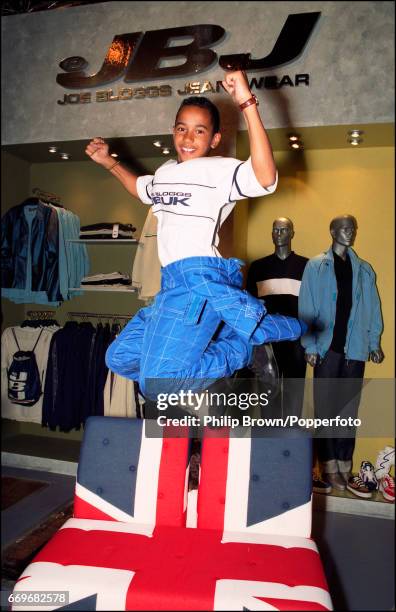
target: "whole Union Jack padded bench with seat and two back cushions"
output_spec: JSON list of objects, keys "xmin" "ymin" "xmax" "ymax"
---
[{"xmin": 12, "ymin": 417, "xmax": 332, "ymax": 610}]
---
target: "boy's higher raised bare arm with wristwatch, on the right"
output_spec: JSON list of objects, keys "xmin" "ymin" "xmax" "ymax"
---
[{"xmin": 223, "ymin": 70, "xmax": 276, "ymax": 187}]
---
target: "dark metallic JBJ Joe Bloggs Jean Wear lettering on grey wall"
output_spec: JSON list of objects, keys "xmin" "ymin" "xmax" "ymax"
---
[{"xmin": 56, "ymin": 12, "xmax": 320, "ymax": 88}]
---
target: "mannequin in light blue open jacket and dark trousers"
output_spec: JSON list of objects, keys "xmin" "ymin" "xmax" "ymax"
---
[{"xmin": 299, "ymin": 215, "xmax": 384, "ymax": 494}]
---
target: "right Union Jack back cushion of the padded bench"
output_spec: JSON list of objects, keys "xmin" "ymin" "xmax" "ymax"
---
[{"xmin": 197, "ymin": 427, "xmax": 312, "ymax": 541}]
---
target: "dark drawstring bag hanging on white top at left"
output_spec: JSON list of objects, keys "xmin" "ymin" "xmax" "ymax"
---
[{"xmin": 7, "ymin": 329, "xmax": 43, "ymax": 406}]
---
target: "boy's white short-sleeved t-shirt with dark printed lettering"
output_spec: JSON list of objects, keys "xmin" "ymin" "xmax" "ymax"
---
[{"xmin": 137, "ymin": 157, "xmax": 278, "ymax": 266}]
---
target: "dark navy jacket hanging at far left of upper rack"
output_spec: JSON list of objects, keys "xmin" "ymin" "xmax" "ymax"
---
[{"xmin": 1, "ymin": 198, "xmax": 61, "ymax": 302}]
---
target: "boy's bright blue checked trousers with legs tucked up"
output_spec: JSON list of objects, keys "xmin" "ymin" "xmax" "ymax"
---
[{"xmin": 106, "ymin": 257, "xmax": 302, "ymax": 399}]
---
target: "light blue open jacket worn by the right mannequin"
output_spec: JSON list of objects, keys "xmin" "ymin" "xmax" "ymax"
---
[{"xmin": 298, "ymin": 247, "xmax": 383, "ymax": 361}]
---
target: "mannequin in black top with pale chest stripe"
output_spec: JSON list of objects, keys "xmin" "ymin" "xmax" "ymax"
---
[{"xmin": 247, "ymin": 217, "xmax": 308, "ymax": 417}]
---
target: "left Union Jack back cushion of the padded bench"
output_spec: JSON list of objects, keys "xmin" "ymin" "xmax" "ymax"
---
[{"xmin": 74, "ymin": 417, "xmax": 189, "ymax": 527}]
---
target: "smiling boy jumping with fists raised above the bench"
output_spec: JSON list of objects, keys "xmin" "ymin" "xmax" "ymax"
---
[{"xmin": 86, "ymin": 71, "xmax": 302, "ymax": 399}]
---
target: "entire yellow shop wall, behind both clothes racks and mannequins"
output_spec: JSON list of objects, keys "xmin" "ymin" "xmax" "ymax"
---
[{"xmin": 2, "ymin": 133, "xmax": 394, "ymax": 466}]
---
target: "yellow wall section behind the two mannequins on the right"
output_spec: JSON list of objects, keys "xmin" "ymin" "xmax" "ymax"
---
[{"xmin": 237, "ymin": 139, "xmax": 395, "ymax": 469}]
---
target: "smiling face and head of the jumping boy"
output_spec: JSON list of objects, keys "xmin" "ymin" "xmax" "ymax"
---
[{"xmin": 173, "ymin": 106, "xmax": 221, "ymax": 162}]
